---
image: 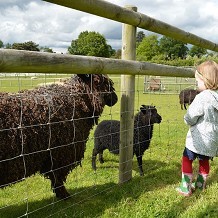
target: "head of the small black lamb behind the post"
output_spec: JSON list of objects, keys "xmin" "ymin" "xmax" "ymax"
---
[{"xmin": 140, "ymin": 105, "xmax": 162, "ymax": 124}]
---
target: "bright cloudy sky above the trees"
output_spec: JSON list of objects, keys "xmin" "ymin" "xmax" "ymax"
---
[{"xmin": 0, "ymin": 0, "xmax": 218, "ymax": 53}]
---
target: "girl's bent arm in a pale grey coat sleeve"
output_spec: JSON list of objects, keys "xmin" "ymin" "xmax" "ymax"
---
[{"xmin": 184, "ymin": 94, "xmax": 204, "ymax": 126}]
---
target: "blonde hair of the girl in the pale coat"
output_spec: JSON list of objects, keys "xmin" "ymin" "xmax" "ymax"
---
[{"xmin": 196, "ymin": 61, "xmax": 218, "ymax": 90}]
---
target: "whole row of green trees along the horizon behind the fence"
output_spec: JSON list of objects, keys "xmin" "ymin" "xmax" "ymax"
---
[{"xmin": 0, "ymin": 31, "xmax": 217, "ymax": 66}]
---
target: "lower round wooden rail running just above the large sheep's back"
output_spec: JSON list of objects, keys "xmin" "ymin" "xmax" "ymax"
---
[{"xmin": 0, "ymin": 49, "xmax": 194, "ymax": 77}]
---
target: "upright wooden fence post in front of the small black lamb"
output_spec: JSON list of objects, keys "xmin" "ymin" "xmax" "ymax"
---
[{"xmin": 119, "ymin": 6, "xmax": 137, "ymax": 183}]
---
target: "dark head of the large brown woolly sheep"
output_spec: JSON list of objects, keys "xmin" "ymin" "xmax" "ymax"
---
[{"xmin": 78, "ymin": 74, "xmax": 118, "ymax": 107}]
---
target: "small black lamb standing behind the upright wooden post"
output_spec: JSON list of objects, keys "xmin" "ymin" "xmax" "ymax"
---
[{"xmin": 92, "ymin": 105, "xmax": 162, "ymax": 176}]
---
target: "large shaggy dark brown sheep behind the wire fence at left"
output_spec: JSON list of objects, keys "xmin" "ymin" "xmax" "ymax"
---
[{"xmin": 0, "ymin": 74, "xmax": 118, "ymax": 199}]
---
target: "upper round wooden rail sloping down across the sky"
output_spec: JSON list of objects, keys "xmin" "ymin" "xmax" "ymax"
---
[{"xmin": 44, "ymin": 0, "xmax": 218, "ymax": 52}]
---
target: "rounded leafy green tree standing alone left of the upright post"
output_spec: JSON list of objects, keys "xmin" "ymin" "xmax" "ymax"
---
[{"xmin": 68, "ymin": 31, "xmax": 114, "ymax": 57}]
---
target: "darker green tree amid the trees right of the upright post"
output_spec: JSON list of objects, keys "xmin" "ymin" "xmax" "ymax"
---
[{"xmin": 159, "ymin": 36, "xmax": 188, "ymax": 59}]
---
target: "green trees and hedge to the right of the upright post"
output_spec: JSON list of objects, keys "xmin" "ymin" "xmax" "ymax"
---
[{"xmin": 136, "ymin": 31, "xmax": 218, "ymax": 66}]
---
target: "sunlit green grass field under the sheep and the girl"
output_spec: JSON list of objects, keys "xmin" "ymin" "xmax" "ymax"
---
[{"xmin": 0, "ymin": 74, "xmax": 218, "ymax": 218}]
